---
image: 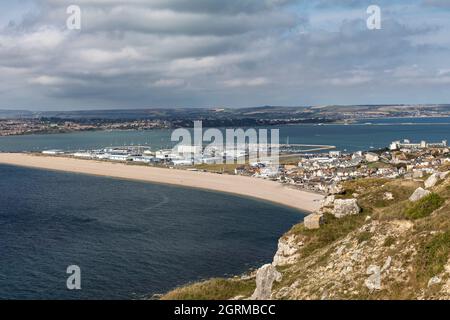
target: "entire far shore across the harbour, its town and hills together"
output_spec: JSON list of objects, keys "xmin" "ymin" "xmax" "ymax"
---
[{"xmin": 0, "ymin": 105, "xmax": 450, "ymax": 136}]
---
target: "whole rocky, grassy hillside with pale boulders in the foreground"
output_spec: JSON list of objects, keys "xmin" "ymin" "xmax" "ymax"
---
[{"xmin": 163, "ymin": 170, "xmax": 450, "ymax": 299}]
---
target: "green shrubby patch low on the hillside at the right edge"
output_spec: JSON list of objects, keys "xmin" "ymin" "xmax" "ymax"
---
[{"xmin": 416, "ymin": 231, "xmax": 450, "ymax": 281}]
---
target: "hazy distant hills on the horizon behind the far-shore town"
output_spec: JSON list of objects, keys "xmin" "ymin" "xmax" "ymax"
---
[{"xmin": 0, "ymin": 105, "xmax": 450, "ymax": 121}]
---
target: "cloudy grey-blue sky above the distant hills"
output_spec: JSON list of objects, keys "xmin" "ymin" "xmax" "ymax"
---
[{"xmin": 0, "ymin": 0, "xmax": 450, "ymax": 110}]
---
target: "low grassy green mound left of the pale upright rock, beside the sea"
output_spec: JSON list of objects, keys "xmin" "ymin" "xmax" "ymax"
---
[{"xmin": 161, "ymin": 278, "xmax": 256, "ymax": 300}]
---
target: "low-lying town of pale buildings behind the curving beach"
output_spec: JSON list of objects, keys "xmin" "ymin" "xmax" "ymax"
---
[{"xmin": 42, "ymin": 139, "xmax": 450, "ymax": 194}]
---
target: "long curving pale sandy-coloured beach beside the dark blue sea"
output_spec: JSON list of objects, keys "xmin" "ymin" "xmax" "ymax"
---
[{"xmin": 0, "ymin": 153, "xmax": 323, "ymax": 212}]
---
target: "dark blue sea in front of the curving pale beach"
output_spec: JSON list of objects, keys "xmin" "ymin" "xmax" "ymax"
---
[{"xmin": 0, "ymin": 166, "xmax": 303, "ymax": 299}]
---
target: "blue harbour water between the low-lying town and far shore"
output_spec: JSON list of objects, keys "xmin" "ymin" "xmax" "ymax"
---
[{"xmin": 0, "ymin": 118, "xmax": 450, "ymax": 151}]
